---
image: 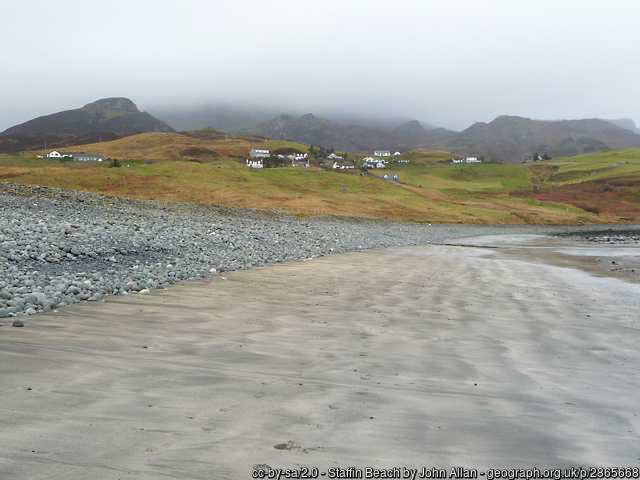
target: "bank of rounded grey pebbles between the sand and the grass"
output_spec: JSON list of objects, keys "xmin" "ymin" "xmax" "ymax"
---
[{"xmin": 0, "ymin": 182, "xmax": 640, "ymax": 324}]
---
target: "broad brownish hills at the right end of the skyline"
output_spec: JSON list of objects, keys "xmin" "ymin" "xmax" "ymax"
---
[{"xmin": 422, "ymin": 116, "xmax": 640, "ymax": 163}]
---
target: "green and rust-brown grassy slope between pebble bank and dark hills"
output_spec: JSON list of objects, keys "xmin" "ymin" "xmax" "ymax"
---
[{"xmin": 5, "ymin": 133, "xmax": 640, "ymax": 224}]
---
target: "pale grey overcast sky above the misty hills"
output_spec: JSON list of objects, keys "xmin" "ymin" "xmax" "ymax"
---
[{"xmin": 0, "ymin": 0, "xmax": 640, "ymax": 131}]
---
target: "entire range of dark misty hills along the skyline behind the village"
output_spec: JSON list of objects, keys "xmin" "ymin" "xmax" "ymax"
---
[{"xmin": 0, "ymin": 97, "xmax": 640, "ymax": 163}]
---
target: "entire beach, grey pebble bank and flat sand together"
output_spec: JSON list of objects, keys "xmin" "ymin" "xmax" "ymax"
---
[{"xmin": 0, "ymin": 183, "xmax": 640, "ymax": 480}]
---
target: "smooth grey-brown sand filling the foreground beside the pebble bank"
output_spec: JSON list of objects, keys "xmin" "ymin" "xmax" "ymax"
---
[{"xmin": 0, "ymin": 238, "xmax": 640, "ymax": 480}]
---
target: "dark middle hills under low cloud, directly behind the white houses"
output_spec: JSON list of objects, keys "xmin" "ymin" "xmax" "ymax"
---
[{"xmin": 236, "ymin": 113, "xmax": 455, "ymax": 153}]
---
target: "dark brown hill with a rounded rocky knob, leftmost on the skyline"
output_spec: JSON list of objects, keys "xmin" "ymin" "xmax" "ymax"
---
[{"xmin": 2, "ymin": 98, "xmax": 175, "ymax": 135}]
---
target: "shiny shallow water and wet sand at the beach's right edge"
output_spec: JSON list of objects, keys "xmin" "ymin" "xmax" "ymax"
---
[{"xmin": 455, "ymin": 235, "xmax": 640, "ymax": 283}]
